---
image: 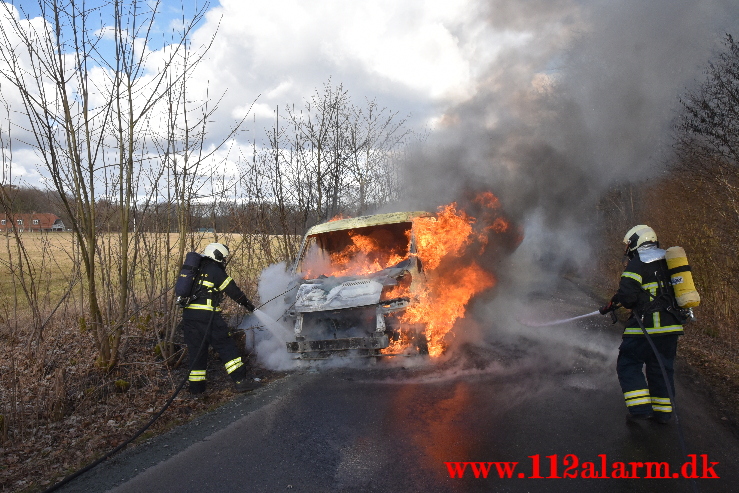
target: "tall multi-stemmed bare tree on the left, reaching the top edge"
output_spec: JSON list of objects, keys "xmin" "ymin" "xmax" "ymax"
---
[{"xmin": 0, "ymin": 0, "xmax": 214, "ymax": 368}]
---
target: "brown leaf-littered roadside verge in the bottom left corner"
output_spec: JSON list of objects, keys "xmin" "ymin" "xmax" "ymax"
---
[{"xmin": 0, "ymin": 302, "xmax": 276, "ymax": 491}]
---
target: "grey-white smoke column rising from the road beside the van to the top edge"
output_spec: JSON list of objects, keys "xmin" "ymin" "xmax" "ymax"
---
[{"xmin": 390, "ymin": 0, "xmax": 739, "ymax": 369}]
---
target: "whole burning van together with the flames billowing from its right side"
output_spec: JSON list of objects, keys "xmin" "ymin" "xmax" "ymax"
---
[{"xmin": 286, "ymin": 192, "xmax": 521, "ymax": 359}]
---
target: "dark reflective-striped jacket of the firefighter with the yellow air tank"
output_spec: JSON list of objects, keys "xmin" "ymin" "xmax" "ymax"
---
[{"xmin": 611, "ymin": 244, "xmax": 683, "ymax": 337}]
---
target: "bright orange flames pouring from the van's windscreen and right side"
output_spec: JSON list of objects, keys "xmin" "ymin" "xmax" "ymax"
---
[{"xmin": 303, "ymin": 192, "xmax": 520, "ymax": 357}]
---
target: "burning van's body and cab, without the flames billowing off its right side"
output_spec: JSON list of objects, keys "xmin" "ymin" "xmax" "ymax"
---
[{"xmin": 287, "ymin": 212, "xmax": 434, "ymax": 359}]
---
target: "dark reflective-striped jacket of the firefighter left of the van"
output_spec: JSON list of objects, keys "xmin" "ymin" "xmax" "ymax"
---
[{"xmin": 182, "ymin": 257, "xmax": 254, "ymax": 319}]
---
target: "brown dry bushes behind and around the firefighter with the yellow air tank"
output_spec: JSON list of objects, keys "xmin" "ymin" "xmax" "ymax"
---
[{"xmin": 597, "ymin": 170, "xmax": 739, "ymax": 424}]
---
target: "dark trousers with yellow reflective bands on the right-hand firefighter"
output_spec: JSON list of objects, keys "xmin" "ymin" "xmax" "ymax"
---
[{"xmin": 616, "ymin": 334, "xmax": 679, "ymax": 418}]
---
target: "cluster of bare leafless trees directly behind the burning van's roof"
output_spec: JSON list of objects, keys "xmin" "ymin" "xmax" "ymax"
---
[{"xmin": 278, "ymin": 80, "xmax": 411, "ymax": 227}]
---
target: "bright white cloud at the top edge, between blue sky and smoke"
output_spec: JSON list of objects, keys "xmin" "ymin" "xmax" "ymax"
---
[{"xmin": 206, "ymin": 0, "xmax": 481, "ymax": 98}]
